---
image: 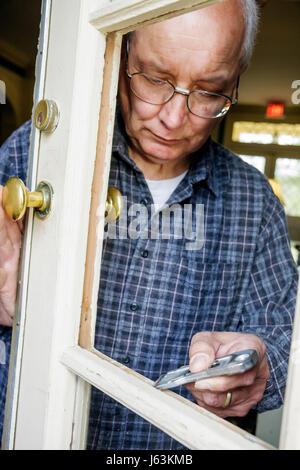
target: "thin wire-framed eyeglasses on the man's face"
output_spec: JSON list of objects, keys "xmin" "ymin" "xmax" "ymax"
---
[{"xmin": 126, "ymin": 42, "xmax": 240, "ymax": 119}]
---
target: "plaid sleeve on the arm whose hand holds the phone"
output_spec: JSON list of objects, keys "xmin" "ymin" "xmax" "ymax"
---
[{"xmin": 242, "ymin": 185, "xmax": 298, "ymax": 412}]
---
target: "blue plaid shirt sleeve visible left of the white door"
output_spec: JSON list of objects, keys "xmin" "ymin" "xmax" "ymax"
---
[{"xmin": 0, "ymin": 121, "xmax": 31, "ymax": 186}]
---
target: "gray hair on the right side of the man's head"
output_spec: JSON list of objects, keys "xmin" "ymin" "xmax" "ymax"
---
[{"xmin": 240, "ymin": 0, "xmax": 259, "ymax": 66}]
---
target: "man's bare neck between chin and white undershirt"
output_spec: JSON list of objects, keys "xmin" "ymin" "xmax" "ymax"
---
[{"xmin": 128, "ymin": 147, "xmax": 191, "ymax": 180}]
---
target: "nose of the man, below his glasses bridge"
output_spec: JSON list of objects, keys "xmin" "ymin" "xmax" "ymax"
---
[{"xmin": 159, "ymin": 93, "xmax": 189, "ymax": 130}]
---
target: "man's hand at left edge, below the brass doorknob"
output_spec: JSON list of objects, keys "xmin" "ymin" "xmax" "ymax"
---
[{"xmin": 0, "ymin": 186, "xmax": 22, "ymax": 326}]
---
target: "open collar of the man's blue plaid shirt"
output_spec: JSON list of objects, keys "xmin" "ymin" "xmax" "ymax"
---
[{"xmin": 112, "ymin": 105, "xmax": 230, "ymax": 196}]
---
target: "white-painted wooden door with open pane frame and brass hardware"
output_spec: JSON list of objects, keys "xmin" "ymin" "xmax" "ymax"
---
[{"xmin": 3, "ymin": 0, "xmax": 299, "ymax": 449}]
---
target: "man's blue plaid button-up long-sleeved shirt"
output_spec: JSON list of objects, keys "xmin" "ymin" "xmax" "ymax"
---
[{"xmin": 0, "ymin": 112, "xmax": 298, "ymax": 450}]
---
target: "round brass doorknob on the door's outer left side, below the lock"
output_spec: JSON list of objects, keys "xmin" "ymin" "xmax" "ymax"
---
[{"xmin": 3, "ymin": 177, "xmax": 53, "ymax": 221}]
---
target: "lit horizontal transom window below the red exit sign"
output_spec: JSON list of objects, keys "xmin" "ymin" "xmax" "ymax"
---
[{"xmin": 232, "ymin": 121, "xmax": 300, "ymax": 145}]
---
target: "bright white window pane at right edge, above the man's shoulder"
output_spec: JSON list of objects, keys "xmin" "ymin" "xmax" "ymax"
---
[{"xmin": 275, "ymin": 158, "xmax": 300, "ymax": 217}]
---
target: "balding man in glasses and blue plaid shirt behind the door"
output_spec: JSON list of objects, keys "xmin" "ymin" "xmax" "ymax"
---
[{"xmin": 0, "ymin": 0, "xmax": 297, "ymax": 449}]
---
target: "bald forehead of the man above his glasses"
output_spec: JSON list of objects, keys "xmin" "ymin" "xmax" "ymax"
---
[{"xmin": 130, "ymin": 9, "xmax": 243, "ymax": 82}]
